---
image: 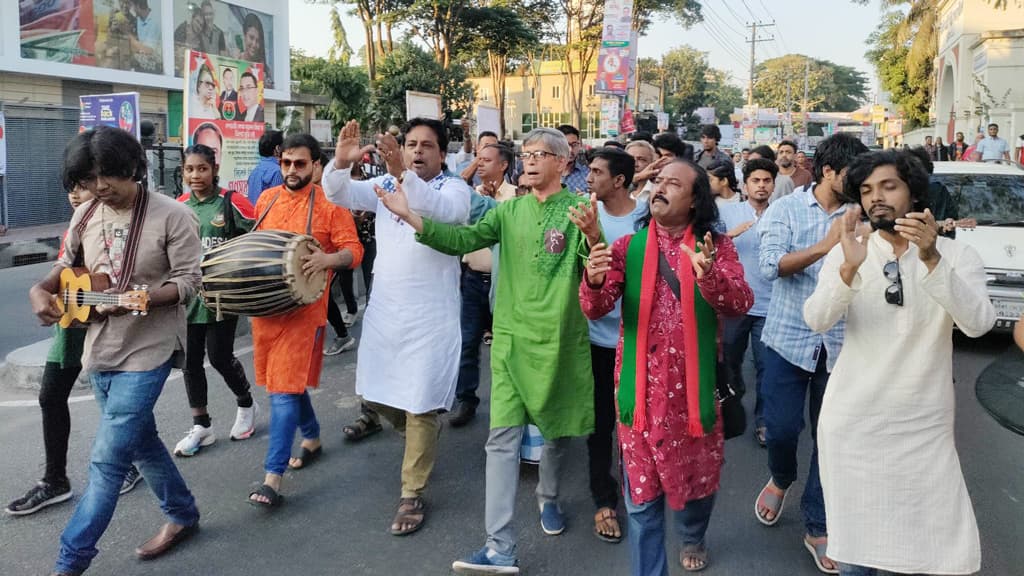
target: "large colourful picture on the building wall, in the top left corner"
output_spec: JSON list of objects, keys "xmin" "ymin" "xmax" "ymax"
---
[{"xmin": 18, "ymin": 0, "xmax": 163, "ymax": 74}]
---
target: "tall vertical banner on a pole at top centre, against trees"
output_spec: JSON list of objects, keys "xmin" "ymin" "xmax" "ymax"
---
[{"xmin": 594, "ymin": 0, "xmax": 633, "ymax": 96}]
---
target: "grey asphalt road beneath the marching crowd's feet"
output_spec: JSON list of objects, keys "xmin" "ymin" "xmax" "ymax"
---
[{"xmin": 0, "ymin": 261, "xmax": 1024, "ymax": 576}]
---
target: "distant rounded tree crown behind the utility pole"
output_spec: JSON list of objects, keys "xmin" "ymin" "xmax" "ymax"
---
[{"xmin": 754, "ymin": 54, "xmax": 867, "ymax": 112}]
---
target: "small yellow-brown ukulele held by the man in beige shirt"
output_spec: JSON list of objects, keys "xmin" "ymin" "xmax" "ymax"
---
[{"xmin": 56, "ymin": 268, "xmax": 150, "ymax": 328}]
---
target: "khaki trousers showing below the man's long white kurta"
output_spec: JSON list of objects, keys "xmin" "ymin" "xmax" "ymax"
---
[{"xmin": 367, "ymin": 402, "xmax": 441, "ymax": 498}]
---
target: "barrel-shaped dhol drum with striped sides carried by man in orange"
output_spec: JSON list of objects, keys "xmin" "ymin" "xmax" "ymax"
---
[{"xmin": 201, "ymin": 230, "xmax": 327, "ymax": 319}]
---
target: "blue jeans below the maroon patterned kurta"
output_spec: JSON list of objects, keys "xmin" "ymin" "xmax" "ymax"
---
[{"xmin": 623, "ymin": 469, "xmax": 715, "ymax": 576}]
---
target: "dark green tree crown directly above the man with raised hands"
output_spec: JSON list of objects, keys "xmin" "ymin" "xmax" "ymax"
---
[{"xmin": 368, "ymin": 40, "xmax": 473, "ymax": 128}]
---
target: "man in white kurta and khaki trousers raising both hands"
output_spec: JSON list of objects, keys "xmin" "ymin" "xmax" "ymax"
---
[{"xmin": 324, "ymin": 119, "xmax": 472, "ymax": 536}]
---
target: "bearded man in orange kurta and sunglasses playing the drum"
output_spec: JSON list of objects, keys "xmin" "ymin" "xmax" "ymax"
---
[{"xmin": 249, "ymin": 134, "xmax": 362, "ymax": 508}]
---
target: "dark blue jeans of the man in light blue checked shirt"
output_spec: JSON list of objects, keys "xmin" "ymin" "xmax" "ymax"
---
[{"xmin": 762, "ymin": 346, "xmax": 828, "ymax": 537}]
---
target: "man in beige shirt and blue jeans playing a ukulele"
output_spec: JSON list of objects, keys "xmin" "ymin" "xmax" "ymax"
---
[{"xmin": 30, "ymin": 127, "xmax": 202, "ymax": 575}]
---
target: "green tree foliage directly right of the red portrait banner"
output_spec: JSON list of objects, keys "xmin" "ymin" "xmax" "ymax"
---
[{"xmin": 292, "ymin": 48, "xmax": 370, "ymax": 130}]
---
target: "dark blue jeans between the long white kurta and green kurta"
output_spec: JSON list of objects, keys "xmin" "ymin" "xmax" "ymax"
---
[{"xmin": 455, "ymin": 268, "xmax": 490, "ymax": 407}]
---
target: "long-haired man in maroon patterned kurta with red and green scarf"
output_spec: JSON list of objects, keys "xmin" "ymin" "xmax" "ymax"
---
[{"xmin": 580, "ymin": 160, "xmax": 754, "ymax": 576}]
